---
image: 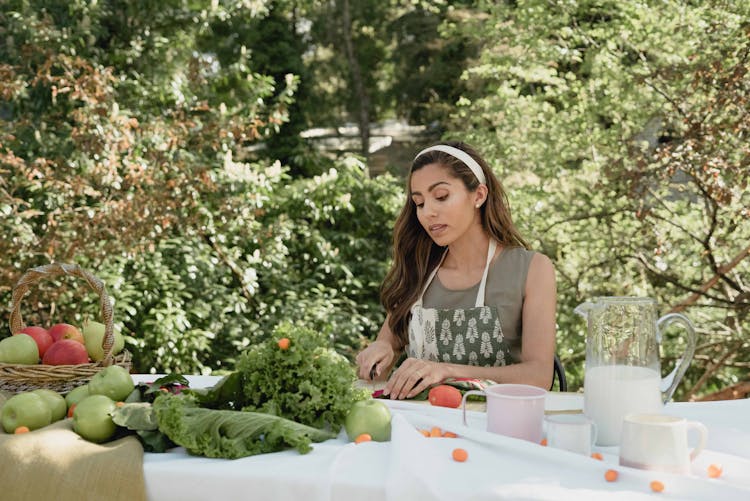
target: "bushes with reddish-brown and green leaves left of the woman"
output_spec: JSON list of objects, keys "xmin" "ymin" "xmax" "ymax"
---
[{"xmin": 0, "ymin": 0, "xmax": 396, "ymax": 372}]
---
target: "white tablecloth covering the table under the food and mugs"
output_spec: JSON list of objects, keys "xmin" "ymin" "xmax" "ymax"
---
[{"xmin": 136, "ymin": 376, "xmax": 750, "ymax": 501}]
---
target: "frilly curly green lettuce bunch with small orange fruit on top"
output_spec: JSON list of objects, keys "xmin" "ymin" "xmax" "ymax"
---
[{"xmin": 191, "ymin": 323, "xmax": 368, "ymax": 432}]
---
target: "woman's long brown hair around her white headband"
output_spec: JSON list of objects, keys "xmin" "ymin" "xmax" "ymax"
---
[{"xmin": 380, "ymin": 141, "xmax": 528, "ymax": 348}]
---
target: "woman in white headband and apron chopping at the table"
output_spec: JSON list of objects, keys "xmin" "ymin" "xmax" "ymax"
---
[{"xmin": 357, "ymin": 142, "xmax": 556, "ymax": 399}]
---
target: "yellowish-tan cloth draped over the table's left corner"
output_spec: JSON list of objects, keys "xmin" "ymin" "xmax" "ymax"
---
[{"xmin": 0, "ymin": 419, "xmax": 146, "ymax": 501}]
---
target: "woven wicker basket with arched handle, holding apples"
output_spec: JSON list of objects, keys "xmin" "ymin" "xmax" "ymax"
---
[{"xmin": 0, "ymin": 263, "xmax": 131, "ymax": 393}]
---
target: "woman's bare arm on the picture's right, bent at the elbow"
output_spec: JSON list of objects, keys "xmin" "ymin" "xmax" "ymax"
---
[{"xmin": 383, "ymin": 253, "xmax": 557, "ymax": 398}]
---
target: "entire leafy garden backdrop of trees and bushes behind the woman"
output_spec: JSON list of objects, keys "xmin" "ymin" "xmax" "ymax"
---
[{"xmin": 0, "ymin": 0, "xmax": 750, "ymax": 399}]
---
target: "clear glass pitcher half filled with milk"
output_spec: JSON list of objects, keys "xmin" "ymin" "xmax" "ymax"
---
[{"xmin": 574, "ymin": 297, "xmax": 695, "ymax": 446}]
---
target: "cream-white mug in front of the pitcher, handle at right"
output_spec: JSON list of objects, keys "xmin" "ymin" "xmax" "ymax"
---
[{"xmin": 620, "ymin": 414, "xmax": 708, "ymax": 473}]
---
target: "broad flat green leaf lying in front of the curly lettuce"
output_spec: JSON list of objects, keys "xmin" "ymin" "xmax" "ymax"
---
[{"xmin": 153, "ymin": 393, "xmax": 336, "ymax": 459}]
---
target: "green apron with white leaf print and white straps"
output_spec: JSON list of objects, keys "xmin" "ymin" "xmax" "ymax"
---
[{"xmin": 406, "ymin": 239, "xmax": 512, "ymax": 367}]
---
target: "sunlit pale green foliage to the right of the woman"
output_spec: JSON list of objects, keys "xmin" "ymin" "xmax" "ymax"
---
[{"xmin": 450, "ymin": 0, "xmax": 750, "ymax": 397}]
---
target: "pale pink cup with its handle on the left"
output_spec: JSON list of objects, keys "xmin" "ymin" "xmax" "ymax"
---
[{"xmin": 461, "ymin": 384, "xmax": 547, "ymax": 443}]
